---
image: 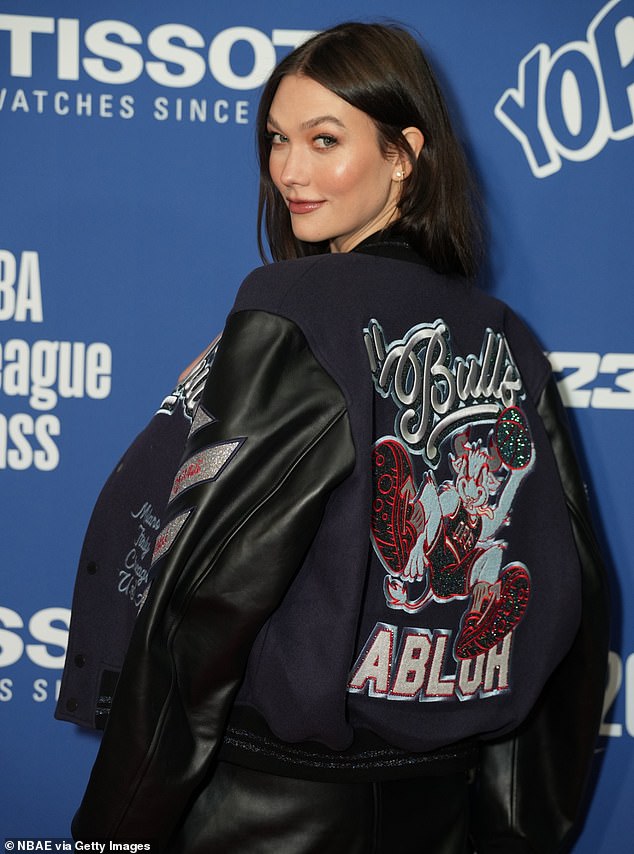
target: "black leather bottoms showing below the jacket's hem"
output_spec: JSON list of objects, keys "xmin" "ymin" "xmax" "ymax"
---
[{"xmin": 169, "ymin": 762, "xmax": 468, "ymax": 854}]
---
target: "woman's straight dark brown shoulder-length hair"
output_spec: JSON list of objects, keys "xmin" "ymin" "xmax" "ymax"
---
[{"xmin": 257, "ymin": 23, "xmax": 481, "ymax": 276}]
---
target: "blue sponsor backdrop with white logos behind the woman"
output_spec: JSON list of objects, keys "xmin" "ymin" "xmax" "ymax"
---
[{"xmin": 0, "ymin": 0, "xmax": 634, "ymax": 854}]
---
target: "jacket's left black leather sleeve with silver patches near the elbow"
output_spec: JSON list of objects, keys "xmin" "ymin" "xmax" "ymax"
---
[{"xmin": 73, "ymin": 311, "xmax": 355, "ymax": 850}]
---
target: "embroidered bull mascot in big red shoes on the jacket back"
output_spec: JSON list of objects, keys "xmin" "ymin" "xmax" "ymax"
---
[{"xmin": 371, "ymin": 426, "xmax": 534, "ymax": 636}]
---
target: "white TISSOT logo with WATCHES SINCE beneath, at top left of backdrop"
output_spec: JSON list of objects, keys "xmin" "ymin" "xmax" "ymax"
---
[{"xmin": 0, "ymin": 14, "xmax": 314, "ymax": 125}]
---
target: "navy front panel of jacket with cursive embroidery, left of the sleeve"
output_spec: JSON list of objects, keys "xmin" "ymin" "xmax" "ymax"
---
[{"xmin": 55, "ymin": 342, "xmax": 216, "ymax": 730}]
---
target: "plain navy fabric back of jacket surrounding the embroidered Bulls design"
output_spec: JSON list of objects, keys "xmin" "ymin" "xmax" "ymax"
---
[{"xmin": 234, "ymin": 253, "xmax": 579, "ymax": 762}]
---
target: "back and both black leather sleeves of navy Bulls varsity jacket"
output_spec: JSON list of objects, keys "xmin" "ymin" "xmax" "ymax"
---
[{"xmin": 73, "ymin": 239, "xmax": 607, "ymax": 854}]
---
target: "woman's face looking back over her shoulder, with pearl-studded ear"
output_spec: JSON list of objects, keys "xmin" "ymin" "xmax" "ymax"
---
[{"xmin": 267, "ymin": 74, "xmax": 401, "ymax": 252}]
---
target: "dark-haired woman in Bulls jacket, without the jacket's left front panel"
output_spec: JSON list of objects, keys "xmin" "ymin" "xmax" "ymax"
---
[{"xmin": 66, "ymin": 24, "xmax": 607, "ymax": 854}]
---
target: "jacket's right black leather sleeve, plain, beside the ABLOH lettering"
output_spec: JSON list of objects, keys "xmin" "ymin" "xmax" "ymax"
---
[{"xmin": 473, "ymin": 378, "xmax": 609, "ymax": 854}]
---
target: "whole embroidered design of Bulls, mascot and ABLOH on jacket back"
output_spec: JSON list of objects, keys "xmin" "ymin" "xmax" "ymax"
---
[{"xmin": 348, "ymin": 319, "xmax": 535, "ymax": 700}]
